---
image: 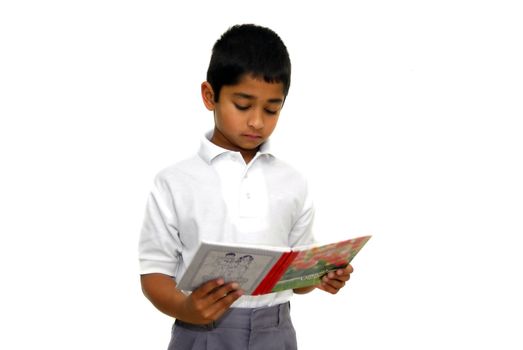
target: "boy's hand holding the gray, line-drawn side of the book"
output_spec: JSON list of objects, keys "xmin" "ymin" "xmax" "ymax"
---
[{"xmin": 180, "ymin": 278, "xmax": 243, "ymax": 324}]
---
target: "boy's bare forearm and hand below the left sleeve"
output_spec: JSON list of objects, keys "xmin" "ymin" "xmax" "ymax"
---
[{"xmin": 140, "ymin": 273, "xmax": 243, "ymax": 324}]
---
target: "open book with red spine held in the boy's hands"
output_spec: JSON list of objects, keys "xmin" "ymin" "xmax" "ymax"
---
[{"xmin": 177, "ymin": 236, "xmax": 371, "ymax": 295}]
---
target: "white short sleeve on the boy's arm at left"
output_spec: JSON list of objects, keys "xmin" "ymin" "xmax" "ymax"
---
[{"xmin": 138, "ymin": 177, "xmax": 182, "ymax": 277}]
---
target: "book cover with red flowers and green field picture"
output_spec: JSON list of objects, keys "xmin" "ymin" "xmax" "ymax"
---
[{"xmin": 272, "ymin": 236, "xmax": 371, "ymax": 292}]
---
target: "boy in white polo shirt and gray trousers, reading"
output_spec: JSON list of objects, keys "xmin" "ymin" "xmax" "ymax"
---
[{"xmin": 140, "ymin": 25, "xmax": 352, "ymax": 350}]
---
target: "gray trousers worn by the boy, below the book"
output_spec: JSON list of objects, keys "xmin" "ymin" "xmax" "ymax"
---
[{"xmin": 168, "ymin": 303, "xmax": 297, "ymax": 350}]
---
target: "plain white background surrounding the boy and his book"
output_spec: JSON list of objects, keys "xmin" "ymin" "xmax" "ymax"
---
[{"xmin": 0, "ymin": 0, "xmax": 523, "ymax": 349}]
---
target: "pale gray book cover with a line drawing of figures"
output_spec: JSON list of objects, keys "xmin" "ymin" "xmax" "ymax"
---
[{"xmin": 177, "ymin": 242, "xmax": 288, "ymax": 295}]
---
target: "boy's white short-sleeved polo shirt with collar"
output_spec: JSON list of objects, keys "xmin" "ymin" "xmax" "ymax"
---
[{"xmin": 139, "ymin": 133, "xmax": 314, "ymax": 308}]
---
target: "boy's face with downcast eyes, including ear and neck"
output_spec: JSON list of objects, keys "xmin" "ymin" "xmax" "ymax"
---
[{"xmin": 202, "ymin": 76, "xmax": 284, "ymax": 162}]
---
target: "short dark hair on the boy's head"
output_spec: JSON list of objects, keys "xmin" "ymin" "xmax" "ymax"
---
[{"xmin": 207, "ymin": 24, "xmax": 291, "ymax": 102}]
